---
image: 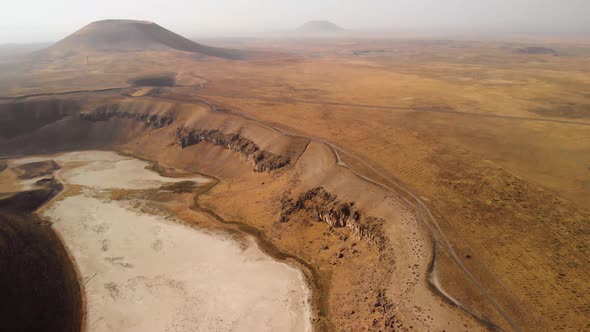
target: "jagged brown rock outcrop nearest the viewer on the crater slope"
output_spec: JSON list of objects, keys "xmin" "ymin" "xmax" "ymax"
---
[{"xmin": 280, "ymin": 187, "xmax": 386, "ymax": 245}]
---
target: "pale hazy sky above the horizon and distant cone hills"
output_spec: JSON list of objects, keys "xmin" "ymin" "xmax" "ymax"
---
[{"xmin": 0, "ymin": 0, "xmax": 590, "ymax": 43}]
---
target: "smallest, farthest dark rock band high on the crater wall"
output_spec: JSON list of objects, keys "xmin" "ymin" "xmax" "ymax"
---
[{"xmin": 80, "ymin": 105, "xmax": 174, "ymax": 129}]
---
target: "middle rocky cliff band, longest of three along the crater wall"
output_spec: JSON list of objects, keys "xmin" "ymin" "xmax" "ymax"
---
[{"xmin": 176, "ymin": 128, "xmax": 290, "ymax": 172}]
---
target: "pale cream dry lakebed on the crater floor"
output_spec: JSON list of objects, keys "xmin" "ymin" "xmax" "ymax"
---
[{"xmin": 37, "ymin": 152, "xmax": 311, "ymax": 331}]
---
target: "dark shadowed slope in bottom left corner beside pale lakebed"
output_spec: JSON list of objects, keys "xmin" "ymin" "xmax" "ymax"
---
[{"xmin": 0, "ymin": 172, "xmax": 84, "ymax": 332}]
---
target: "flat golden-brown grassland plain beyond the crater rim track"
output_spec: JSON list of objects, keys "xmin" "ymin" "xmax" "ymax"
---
[{"xmin": 2, "ymin": 36, "xmax": 590, "ymax": 330}]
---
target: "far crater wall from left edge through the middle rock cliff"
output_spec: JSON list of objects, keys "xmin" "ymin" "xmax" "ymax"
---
[{"xmin": 0, "ymin": 95, "xmax": 298, "ymax": 176}]
